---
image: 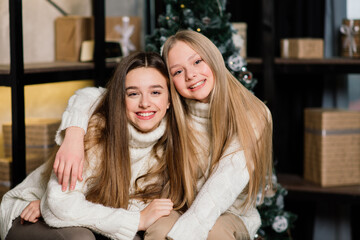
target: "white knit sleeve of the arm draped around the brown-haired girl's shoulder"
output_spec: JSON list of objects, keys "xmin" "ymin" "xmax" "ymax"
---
[{"xmin": 55, "ymin": 87, "xmax": 105, "ymax": 145}]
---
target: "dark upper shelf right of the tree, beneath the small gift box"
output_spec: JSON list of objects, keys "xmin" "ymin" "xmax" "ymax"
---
[{"xmin": 246, "ymin": 57, "xmax": 360, "ymax": 74}]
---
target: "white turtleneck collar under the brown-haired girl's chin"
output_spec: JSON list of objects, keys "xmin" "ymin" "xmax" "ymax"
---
[{"xmin": 128, "ymin": 118, "xmax": 166, "ymax": 148}]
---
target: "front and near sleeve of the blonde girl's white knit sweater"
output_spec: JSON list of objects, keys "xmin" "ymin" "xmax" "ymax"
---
[{"xmin": 168, "ymin": 100, "xmax": 261, "ymax": 240}]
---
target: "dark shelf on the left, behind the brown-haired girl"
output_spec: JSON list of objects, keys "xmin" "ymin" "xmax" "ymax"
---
[{"xmin": 0, "ymin": 62, "xmax": 116, "ymax": 86}]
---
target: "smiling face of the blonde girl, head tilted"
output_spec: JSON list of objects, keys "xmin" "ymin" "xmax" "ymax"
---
[{"xmin": 168, "ymin": 41, "xmax": 215, "ymax": 102}]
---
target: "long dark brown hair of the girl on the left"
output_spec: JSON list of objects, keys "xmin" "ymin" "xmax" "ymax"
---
[{"xmin": 45, "ymin": 52, "xmax": 184, "ymax": 209}]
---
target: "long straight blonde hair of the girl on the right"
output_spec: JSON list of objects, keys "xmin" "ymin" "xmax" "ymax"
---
[{"xmin": 163, "ymin": 30, "xmax": 272, "ymax": 207}]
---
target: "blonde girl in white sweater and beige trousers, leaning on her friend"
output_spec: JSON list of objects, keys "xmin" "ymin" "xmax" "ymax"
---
[{"xmin": 50, "ymin": 30, "xmax": 272, "ymax": 240}]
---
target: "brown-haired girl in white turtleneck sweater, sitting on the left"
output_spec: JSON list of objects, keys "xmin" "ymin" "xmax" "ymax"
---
[{"xmin": 0, "ymin": 53, "xmax": 183, "ymax": 240}]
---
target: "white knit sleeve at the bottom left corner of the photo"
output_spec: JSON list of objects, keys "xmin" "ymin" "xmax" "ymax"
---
[{"xmin": 0, "ymin": 164, "xmax": 46, "ymax": 239}]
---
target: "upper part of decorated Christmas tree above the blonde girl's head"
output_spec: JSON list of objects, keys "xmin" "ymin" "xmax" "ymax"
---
[{"xmin": 146, "ymin": 0, "xmax": 256, "ymax": 90}]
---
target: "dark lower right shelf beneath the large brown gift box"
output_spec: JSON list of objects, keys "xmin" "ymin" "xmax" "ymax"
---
[{"xmin": 277, "ymin": 174, "xmax": 360, "ymax": 204}]
